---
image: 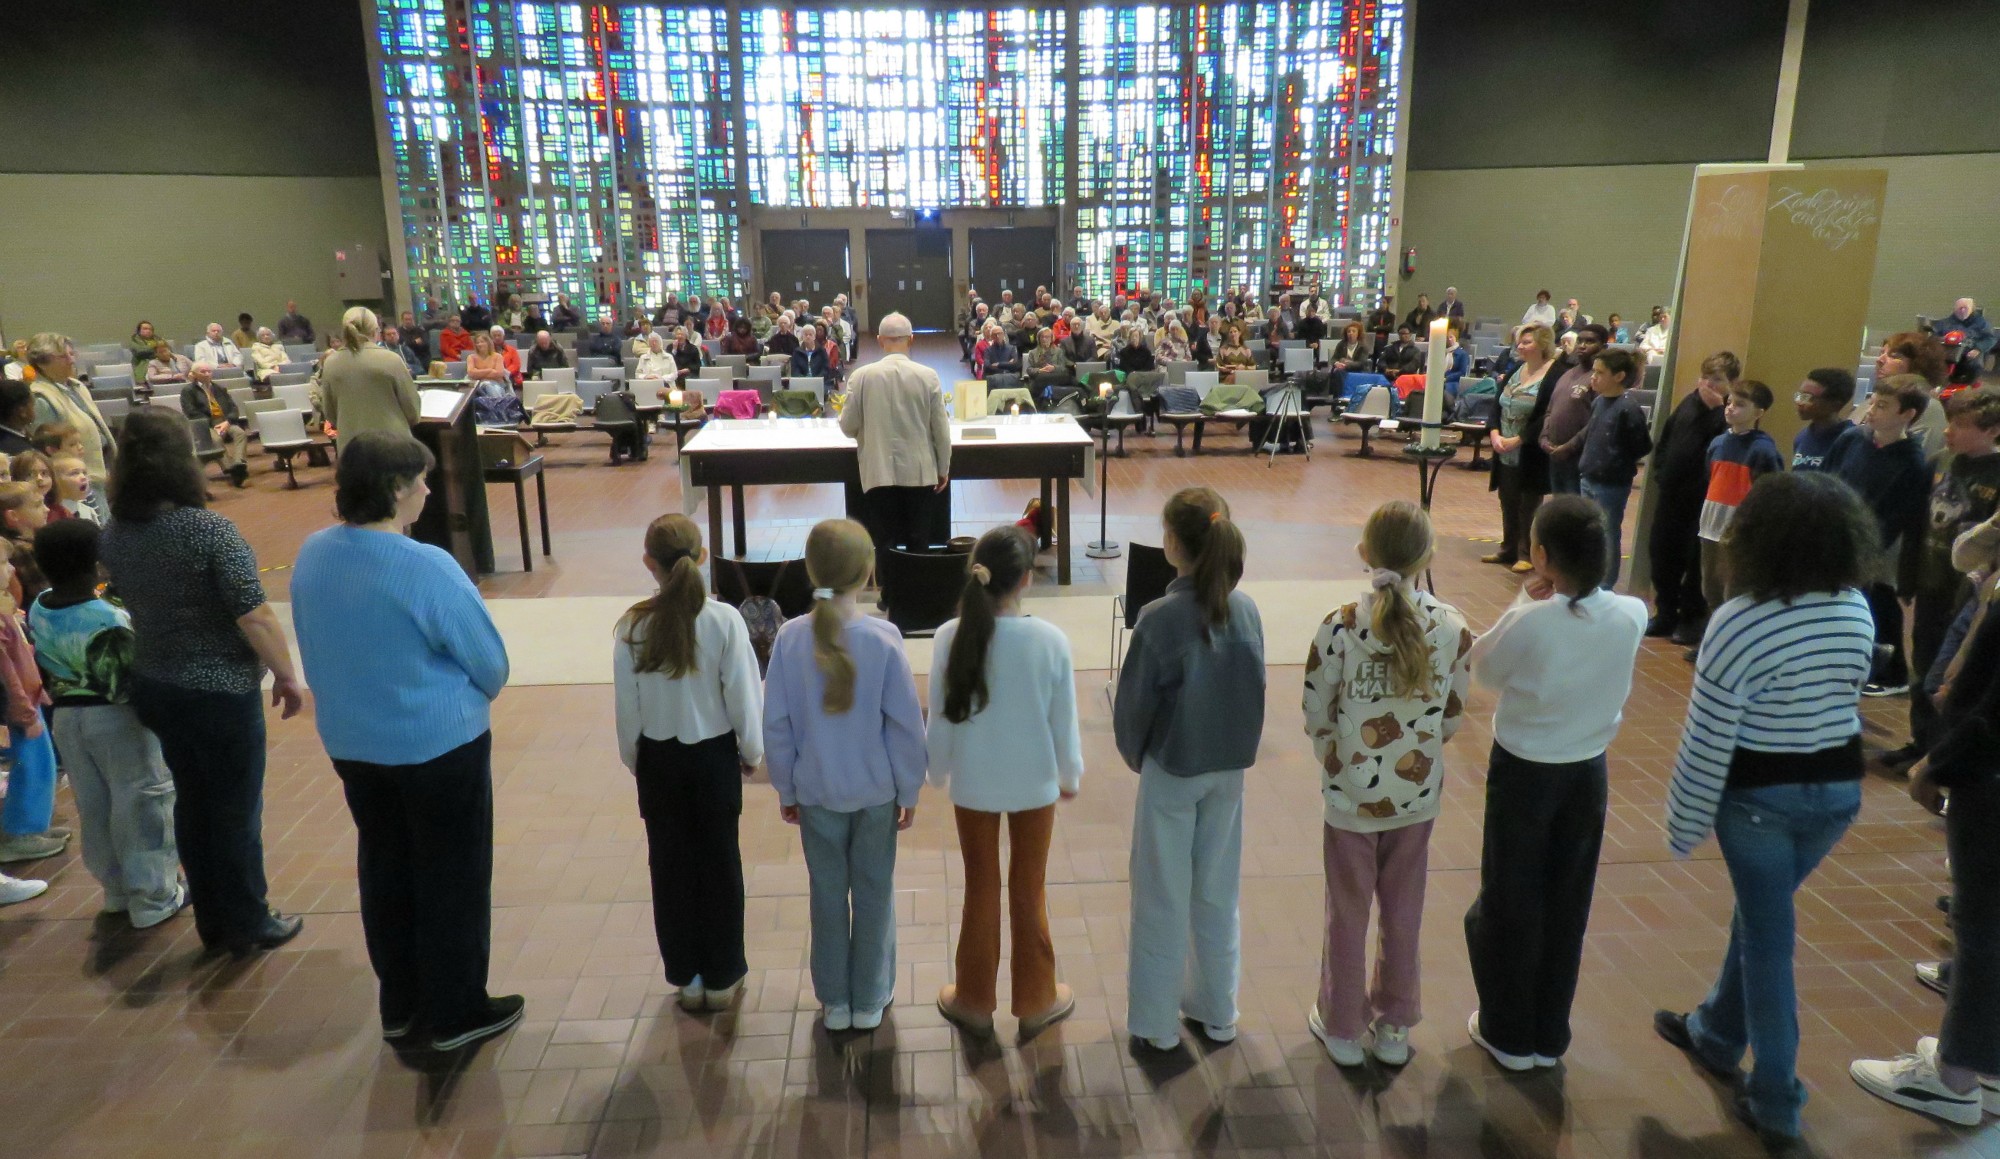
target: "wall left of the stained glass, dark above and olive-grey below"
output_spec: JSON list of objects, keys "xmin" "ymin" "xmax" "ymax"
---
[{"xmin": 0, "ymin": 0, "xmax": 388, "ymax": 342}]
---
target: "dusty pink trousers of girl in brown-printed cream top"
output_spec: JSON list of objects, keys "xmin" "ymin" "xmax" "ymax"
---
[{"xmin": 1320, "ymin": 821, "xmax": 1432, "ymax": 1039}]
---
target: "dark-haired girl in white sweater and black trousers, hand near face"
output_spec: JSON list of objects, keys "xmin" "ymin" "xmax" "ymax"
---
[{"xmin": 1466, "ymin": 496, "xmax": 1646, "ymax": 1071}]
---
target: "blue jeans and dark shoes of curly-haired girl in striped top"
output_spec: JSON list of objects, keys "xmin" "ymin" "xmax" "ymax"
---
[{"xmin": 1688, "ymin": 781, "xmax": 1862, "ymax": 1135}]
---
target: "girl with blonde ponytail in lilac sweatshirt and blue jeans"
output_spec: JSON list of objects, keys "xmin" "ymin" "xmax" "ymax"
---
[{"xmin": 764, "ymin": 520, "xmax": 926, "ymax": 1031}]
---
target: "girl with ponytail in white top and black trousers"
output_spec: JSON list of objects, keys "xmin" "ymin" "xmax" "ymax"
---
[{"xmin": 612, "ymin": 514, "xmax": 764, "ymax": 1011}]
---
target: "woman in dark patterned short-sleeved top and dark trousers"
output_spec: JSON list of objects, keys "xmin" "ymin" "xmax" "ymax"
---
[{"xmin": 100, "ymin": 408, "xmax": 304, "ymax": 955}]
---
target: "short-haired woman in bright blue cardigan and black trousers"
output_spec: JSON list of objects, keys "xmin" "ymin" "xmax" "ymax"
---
[{"xmin": 292, "ymin": 432, "xmax": 526, "ymax": 1051}]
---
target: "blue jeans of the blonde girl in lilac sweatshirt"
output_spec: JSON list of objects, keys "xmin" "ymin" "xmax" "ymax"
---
[{"xmin": 798, "ymin": 801, "xmax": 896, "ymax": 1011}]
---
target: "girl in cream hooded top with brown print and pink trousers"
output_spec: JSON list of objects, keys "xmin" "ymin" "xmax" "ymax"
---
[{"xmin": 1304, "ymin": 500, "xmax": 1472, "ymax": 1067}]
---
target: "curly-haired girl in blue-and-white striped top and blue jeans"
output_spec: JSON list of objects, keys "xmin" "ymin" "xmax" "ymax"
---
[{"xmin": 1654, "ymin": 474, "xmax": 1876, "ymax": 1143}]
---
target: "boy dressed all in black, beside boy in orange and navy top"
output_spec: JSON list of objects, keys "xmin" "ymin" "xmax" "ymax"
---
[{"xmin": 1646, "ymin": 350, "xmax": 1744, "ymax": 645}]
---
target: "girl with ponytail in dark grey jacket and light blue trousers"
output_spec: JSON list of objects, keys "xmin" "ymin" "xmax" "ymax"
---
[{"xmin": 1112, "ymin": 488, "xmax": 1264, "ymax": 1051}]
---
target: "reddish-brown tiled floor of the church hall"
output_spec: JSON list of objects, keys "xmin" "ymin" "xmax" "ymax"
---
[{"xmin": 0, "ymin": 339, "xmax": 2000, "ymax": 1159}]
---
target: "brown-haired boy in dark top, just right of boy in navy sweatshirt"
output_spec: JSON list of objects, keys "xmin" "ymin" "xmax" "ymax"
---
[{"xmin": 1826, "ymin": 374, "xmax": 1930, "ymax": 695}]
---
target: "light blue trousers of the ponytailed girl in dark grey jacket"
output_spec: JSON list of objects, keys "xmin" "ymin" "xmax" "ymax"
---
[{"xmin": 1126, "ymin": 763, "xmax": 1244, "ymax": 1039}]
